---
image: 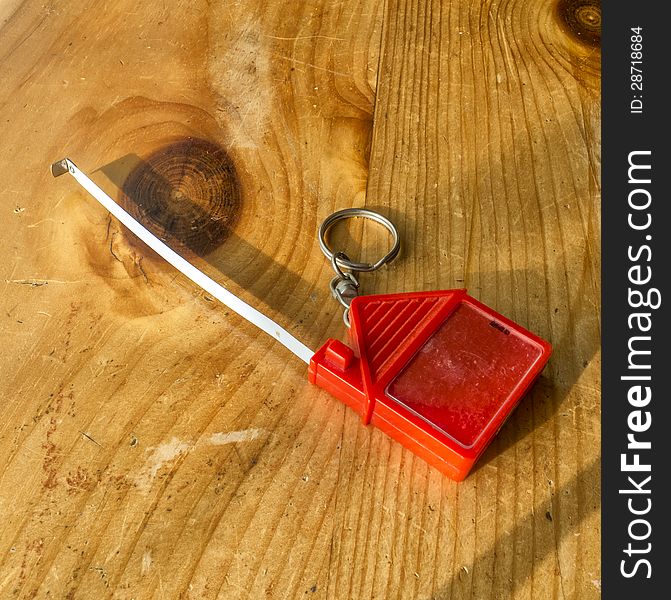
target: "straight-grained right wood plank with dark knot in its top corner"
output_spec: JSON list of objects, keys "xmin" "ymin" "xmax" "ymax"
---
[{"xmin": 329, "ymin": 0, "xmax": 600, "ymax": 599}]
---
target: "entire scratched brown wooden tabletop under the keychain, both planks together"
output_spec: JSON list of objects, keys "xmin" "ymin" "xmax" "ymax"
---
[{"xmin": 0, "ymin": 0, "xmax": 600, "ymax": 600}]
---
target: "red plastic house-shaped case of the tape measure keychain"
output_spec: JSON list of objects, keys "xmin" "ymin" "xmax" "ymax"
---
[{"xmin": 309, "ymin": 290, "xmax": 552, "ymax": 481}]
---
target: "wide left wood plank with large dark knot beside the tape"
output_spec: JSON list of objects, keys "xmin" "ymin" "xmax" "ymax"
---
[{"xmin": 0, "ymin": 2, "xmax": 382, "ymax": 597}]
